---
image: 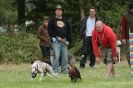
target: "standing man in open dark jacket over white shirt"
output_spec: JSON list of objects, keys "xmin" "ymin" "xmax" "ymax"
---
[{"xmin": 80, "ymin": 7, "xmax": 98, "ymax": 68}]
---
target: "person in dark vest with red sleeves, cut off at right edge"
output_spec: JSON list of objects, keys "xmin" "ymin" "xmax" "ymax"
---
[{"xmin": 121, "ymin": 3, "xmax": 133, "ymax": 66}]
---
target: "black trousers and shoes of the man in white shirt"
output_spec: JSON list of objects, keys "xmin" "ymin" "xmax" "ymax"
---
[{"xmin": 80, "ymin": 37, "xmax": 95, "ymax": 67}]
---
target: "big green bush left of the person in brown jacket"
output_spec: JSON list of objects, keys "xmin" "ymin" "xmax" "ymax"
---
[{"xmin": 0, "ymin": 32, "xmax": 41, "ymax": 64}]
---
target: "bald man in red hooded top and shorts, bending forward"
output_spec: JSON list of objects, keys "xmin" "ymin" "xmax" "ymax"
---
[{"xmin": 92, "ymin": 21, "xmax": 117, "ymax": 77}]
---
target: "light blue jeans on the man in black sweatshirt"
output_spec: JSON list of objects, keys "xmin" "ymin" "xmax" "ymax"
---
[{"xmin": 53, "ymin": 42, "xmax": 68, "ymax": 74}]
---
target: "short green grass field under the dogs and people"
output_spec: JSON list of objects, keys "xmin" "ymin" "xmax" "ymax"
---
[{"xmin": 0, "ymin": 61, "xmax": 133, "ymax": 88}]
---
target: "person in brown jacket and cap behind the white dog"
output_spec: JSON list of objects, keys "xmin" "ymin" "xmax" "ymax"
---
[{"xmin": 37, "ymin": 16, "xmax": 51, "ymax": 65}]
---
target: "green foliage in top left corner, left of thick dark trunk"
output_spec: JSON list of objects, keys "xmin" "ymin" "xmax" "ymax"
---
[{"xmin": 0, "ymin": 0, "xmax": 17, "ymax": 25}]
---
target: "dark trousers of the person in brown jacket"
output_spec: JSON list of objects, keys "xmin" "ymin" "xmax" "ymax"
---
[{"xmin": 40, "ymin": 45, "xmax": 51, "ymax": 65}]
